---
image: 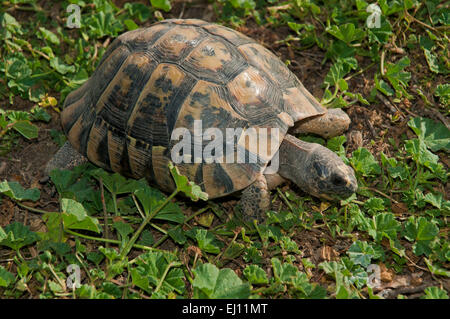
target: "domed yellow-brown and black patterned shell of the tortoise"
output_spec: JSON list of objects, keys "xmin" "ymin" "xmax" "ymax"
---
[{"xmin": 61, "ymin": 19, "xmax": 326, "ymax": 198}]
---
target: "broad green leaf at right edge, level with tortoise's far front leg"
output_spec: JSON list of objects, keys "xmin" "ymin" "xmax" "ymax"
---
[{"xmin": 408, "ymin": 117, "xmax": 450, "ymax": 152}]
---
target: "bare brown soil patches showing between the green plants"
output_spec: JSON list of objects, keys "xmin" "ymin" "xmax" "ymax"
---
[{"xmin": 0, "ymin": 0, "xmax": 450, "ymax": 297}]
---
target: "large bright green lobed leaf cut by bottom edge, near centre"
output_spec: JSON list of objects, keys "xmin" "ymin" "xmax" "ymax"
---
[{"xmin": 192, "ymin": 263, "xmax": 250, "ymax": 299}]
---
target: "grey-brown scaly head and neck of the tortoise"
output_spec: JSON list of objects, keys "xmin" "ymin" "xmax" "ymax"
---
[{"xmin": 279, "ymin": 138, "xmax": 358, "ymax": 200}]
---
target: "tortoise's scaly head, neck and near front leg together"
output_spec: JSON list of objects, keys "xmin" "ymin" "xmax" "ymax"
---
[{"xmin": 240, "ymin": 134, "xmax": 358, "ymax": 221}]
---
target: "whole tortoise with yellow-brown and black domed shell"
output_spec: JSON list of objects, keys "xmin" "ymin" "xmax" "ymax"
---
[{"xmin": 46, "ymin": 19, "xmax": 357, "ymax": 219}]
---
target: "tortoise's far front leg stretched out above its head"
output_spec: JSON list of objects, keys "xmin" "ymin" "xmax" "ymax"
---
[{"xmin": 292, "ymin": 109, "xmax": 350, "ymax": 138}]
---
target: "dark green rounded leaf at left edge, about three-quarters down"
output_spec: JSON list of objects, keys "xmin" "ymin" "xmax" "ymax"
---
[{"xmin": 0, "ymin": 222, "xmax": 39, "ymax": 251}]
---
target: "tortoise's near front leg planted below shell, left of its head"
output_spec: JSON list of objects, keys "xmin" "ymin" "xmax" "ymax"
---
[{"xmin": 239, "ymin": 174, "xmax": 270, "ymax": 222}]
